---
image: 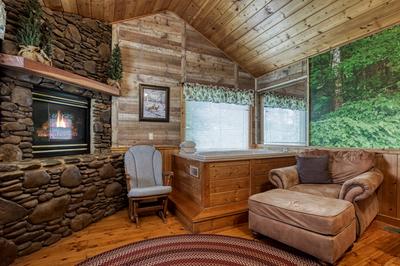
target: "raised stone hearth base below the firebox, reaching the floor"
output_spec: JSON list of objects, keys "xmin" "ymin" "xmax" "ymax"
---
[{"xmin": 0, "ymin": 154, "xmax": 127, "ymax": 260}]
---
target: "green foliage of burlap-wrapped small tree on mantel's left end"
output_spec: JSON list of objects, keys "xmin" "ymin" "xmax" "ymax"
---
[{"xmin": 16, "ymin": 0, "xmax": 42, "ymax": 47}]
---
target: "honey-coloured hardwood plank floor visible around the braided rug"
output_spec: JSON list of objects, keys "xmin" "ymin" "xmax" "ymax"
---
[{"xmin": 15, "ymin": 210, "xmax": 400, "ymax": 266}]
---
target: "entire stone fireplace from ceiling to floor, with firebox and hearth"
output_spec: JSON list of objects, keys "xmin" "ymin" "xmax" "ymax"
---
[{"xmin": 0, "ymin": 0, "xmax": 127, "ymax": 264}]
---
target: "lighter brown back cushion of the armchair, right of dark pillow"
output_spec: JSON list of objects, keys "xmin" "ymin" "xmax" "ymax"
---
[{"xmin": 331, "ymin": 150, "xmax": 375, "ymax": 184}]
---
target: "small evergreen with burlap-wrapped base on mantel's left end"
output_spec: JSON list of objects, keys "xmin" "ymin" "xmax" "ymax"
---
[{"xmin": 16, "ymin": 0, "xmax": 52, "ymax": 65}]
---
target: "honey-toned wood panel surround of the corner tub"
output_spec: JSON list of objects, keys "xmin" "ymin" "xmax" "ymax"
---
[{"xmin": 170, "ymin": 154, "xmax": 296, "ymax": 233}]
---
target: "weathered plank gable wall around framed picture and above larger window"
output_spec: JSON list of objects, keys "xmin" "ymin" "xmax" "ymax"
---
[{"xmin": 112, "ymin": 12, "xmax": 255, "ymax": 146}]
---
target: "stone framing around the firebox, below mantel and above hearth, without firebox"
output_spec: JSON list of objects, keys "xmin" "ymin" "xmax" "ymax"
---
[{"xmin": 0, "ymin": 70, "xmax": 112, "ymax": 161}]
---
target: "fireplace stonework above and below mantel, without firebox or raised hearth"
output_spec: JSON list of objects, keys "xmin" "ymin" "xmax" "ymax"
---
[{"xmin": 0, "ymin": 0, "xmax": 115, "ymax": 161}]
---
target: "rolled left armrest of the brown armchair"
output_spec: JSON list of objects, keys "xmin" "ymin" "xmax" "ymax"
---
[{"xmin": 269, "ymin": 165, "xmax": 299, "ymax": 189}]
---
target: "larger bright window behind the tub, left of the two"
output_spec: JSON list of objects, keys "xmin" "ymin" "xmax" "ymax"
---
[{"xmin": 185, "ymin": 101, "xmax": 250, "ymax": 150}]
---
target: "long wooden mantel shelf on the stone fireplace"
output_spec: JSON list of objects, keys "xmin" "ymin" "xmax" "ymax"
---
[{"xmin": 0, "ymin": 53, "xmax": 119, "ymax": 96}]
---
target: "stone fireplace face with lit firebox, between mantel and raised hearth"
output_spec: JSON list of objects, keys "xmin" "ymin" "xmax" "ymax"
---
[{"xmin": 0, "ymin": 70, "xmax": 111, "ymax": 161}]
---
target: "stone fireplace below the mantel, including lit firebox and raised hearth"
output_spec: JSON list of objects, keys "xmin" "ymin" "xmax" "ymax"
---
[{"xmin": 0, "ymin": 69, "xmax": 127, "ymax": 261}]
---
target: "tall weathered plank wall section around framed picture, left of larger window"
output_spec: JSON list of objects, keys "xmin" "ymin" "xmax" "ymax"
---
[{"xmin": 113, "ymin": 11, "xmax": 183, "ymax": 146}]
